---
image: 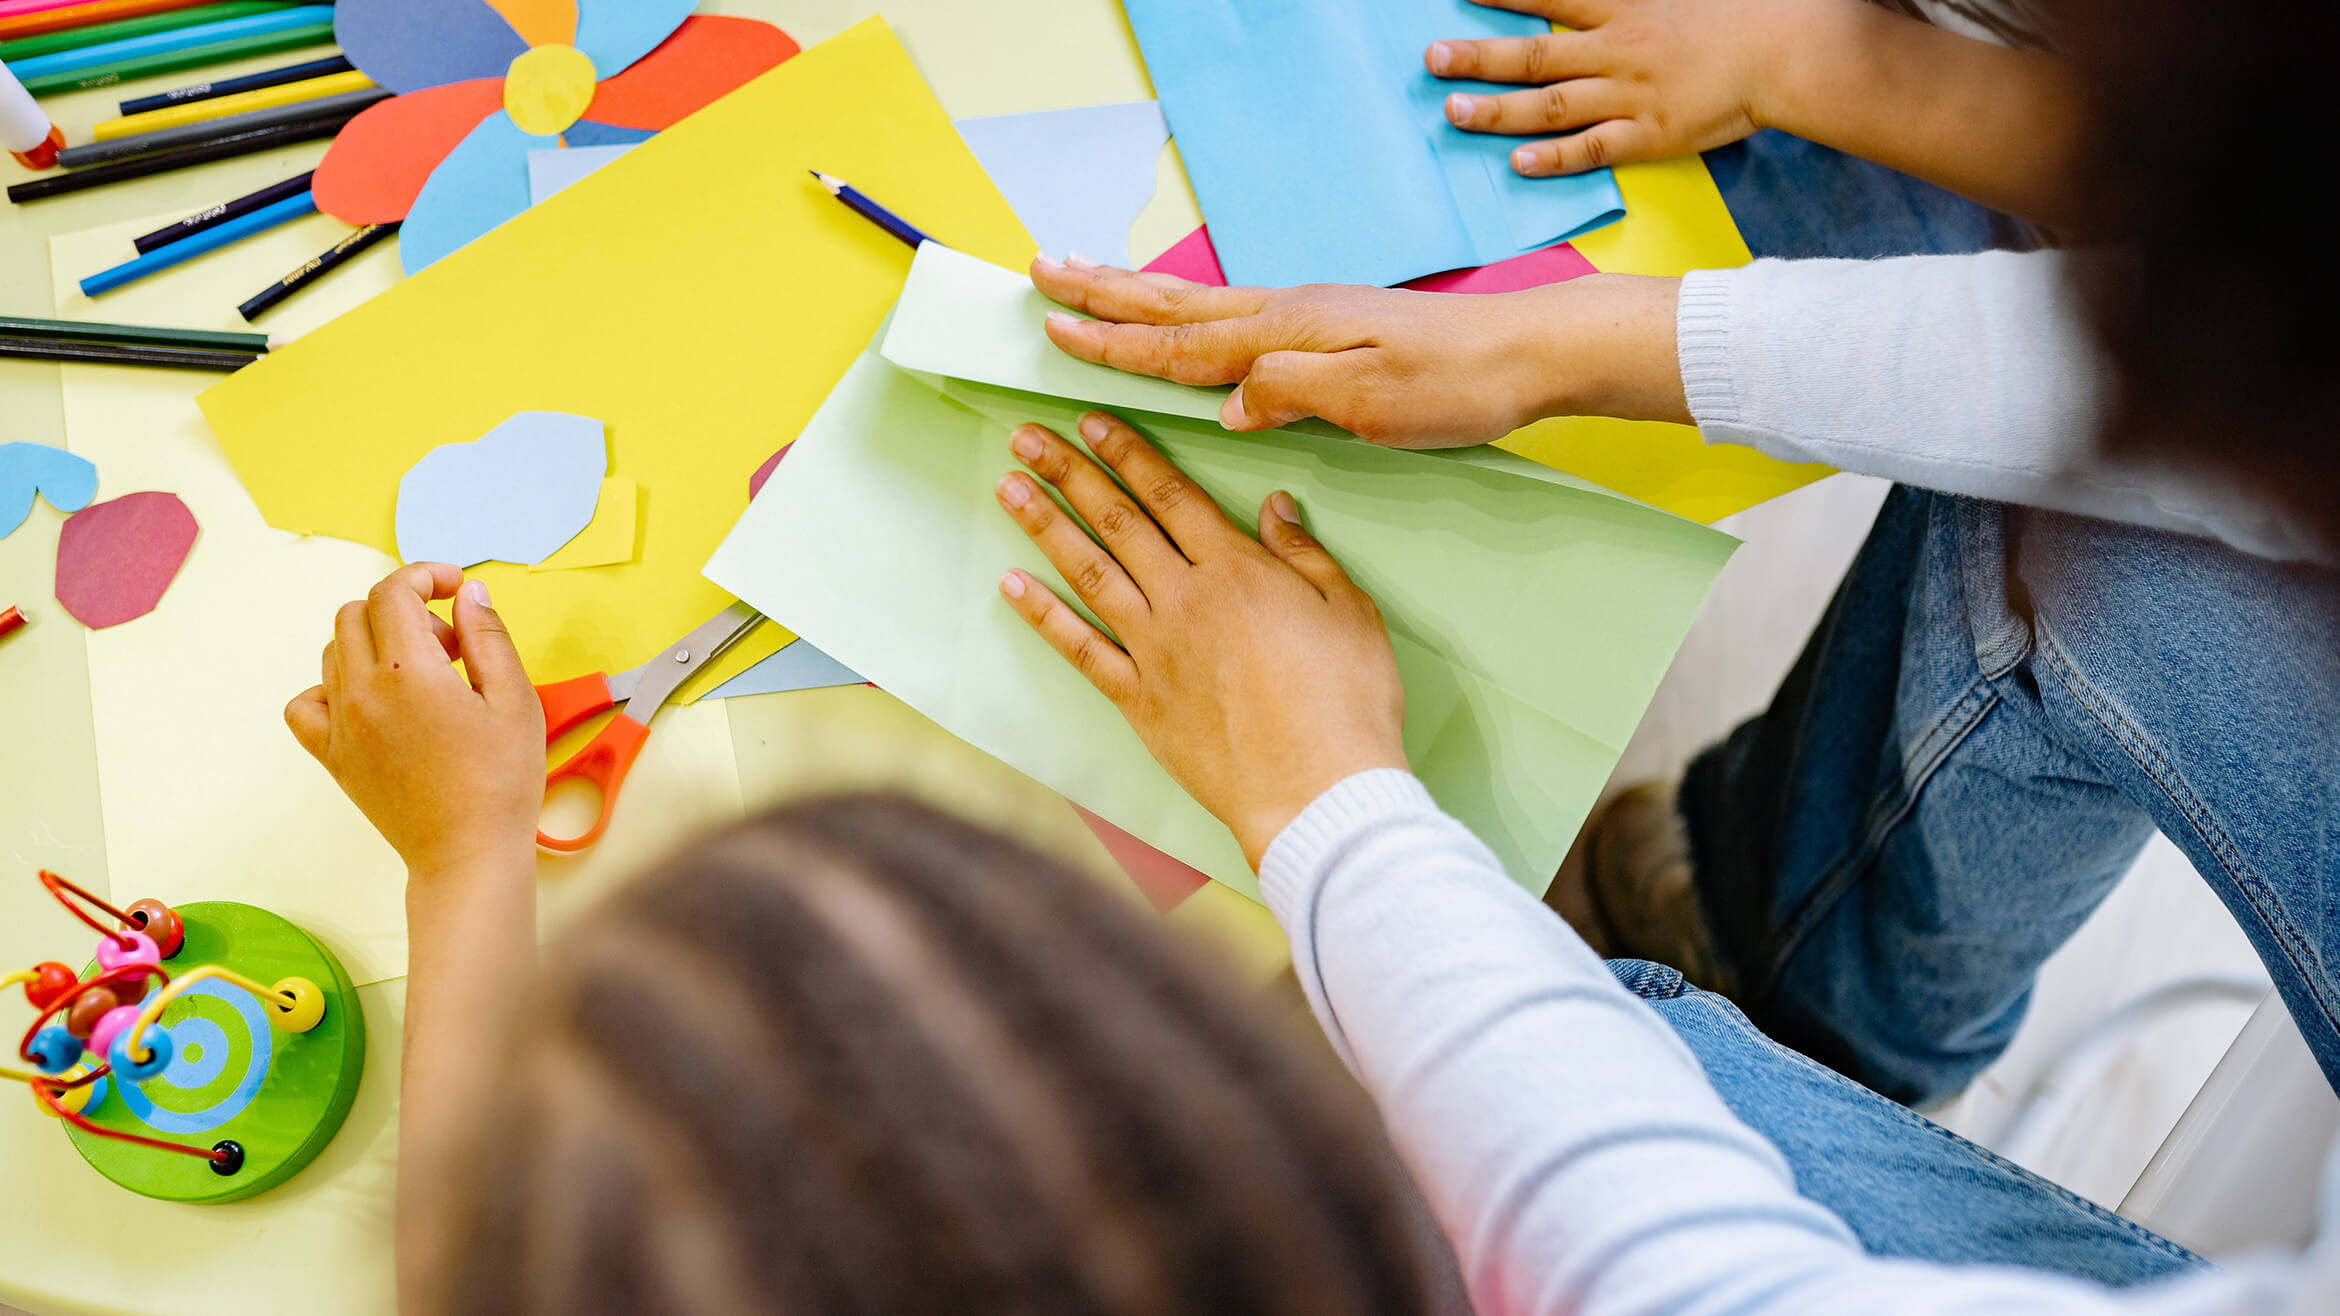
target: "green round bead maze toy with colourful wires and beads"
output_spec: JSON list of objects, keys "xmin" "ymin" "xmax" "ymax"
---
[{"xmin": 0, "ymin": 871, "xmax": 365, "ymax": 1204}]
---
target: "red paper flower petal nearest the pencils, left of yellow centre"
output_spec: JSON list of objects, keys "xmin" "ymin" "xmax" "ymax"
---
[{"xmin": 309, "ymin": 77, "xmax": 503, "ymax": 225}]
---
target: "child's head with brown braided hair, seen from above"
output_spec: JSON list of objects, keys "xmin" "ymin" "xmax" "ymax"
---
[{"xmin": 442, "ymin": 798, "xmax": 1430, "ymax": 1316}]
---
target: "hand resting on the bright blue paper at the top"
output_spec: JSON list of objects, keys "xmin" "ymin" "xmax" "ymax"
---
[{"xmin": 1423, "ymin": 0, "xmax": 1846, "ymax": 176}]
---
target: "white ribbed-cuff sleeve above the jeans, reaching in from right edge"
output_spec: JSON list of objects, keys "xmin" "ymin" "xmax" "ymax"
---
[{"xmin": 1675, "ymin": 251, "xmax": 2333, "ymax": 560}]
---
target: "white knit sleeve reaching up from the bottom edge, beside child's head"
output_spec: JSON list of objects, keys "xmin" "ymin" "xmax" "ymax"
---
[{"xmin": 1259, "ymin": 770, "xmax": 2333, "ymax": 1316}]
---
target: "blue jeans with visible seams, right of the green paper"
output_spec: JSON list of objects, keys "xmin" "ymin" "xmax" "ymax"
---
[{"xmin": 1680, "ymin": 489, "xmax": 2340, "ymax": 1103}]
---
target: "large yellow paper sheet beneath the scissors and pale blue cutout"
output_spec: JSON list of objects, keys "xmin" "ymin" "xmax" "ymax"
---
[{"xmin": 201, "ymin": 19, "xmax": 1032, "ymax": 691}]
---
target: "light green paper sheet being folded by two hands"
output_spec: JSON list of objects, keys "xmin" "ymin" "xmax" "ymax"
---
[{"xmin": 707, "ymin": 248, "xmax": 1734, "ymax": 899}]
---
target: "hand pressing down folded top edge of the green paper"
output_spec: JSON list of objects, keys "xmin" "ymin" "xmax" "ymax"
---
[{"xmin": 1032, "ymin": 258, "xmax": 1689, "ymax": 447}]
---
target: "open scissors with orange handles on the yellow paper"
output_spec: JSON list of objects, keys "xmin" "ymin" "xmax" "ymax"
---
[{"xmin": 536, "ymin": 604, "xmax": 763, "ymax": 855}]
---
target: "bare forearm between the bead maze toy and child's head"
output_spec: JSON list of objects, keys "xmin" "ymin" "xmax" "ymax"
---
[{"xmin": 398, "ymin": 843, "xmax": 536, "ymax": 1311}]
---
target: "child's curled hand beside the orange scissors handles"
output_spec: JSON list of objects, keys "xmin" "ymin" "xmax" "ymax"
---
[{"xmin": 285, "ymin": 562, "xmax": 545, "ymax": 876}]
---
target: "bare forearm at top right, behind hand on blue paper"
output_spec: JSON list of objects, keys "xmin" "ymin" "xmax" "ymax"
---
[{"xmin": 1757, "ymin": 0, "xmax": 2083, "ymax": 225}]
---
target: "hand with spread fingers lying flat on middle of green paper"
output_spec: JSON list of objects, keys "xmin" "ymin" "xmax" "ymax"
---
[{"xmin": 999, "ymin": 412, "xmax": 1406, "ymax": 869}]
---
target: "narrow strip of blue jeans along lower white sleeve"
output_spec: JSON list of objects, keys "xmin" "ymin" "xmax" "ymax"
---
[{"xmin": 1610, "ymin": 960, "xmax": 2202, "ymax": 1286}]
